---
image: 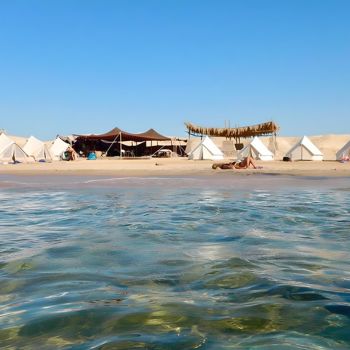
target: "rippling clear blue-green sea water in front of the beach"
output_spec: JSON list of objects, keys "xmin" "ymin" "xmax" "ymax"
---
[{"xmin": 0, "ymin": 176, "xmax": 350, "ymax": 350}]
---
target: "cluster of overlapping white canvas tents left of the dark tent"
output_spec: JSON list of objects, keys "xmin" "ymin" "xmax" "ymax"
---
[{"xmin": 0, "ymin": 133, "xmax": 69, "ymax": 163}]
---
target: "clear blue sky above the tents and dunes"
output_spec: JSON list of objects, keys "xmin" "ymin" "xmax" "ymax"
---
[{"xmin": 0, "ymin": 0, "xmax": 350, "ymax": 139}]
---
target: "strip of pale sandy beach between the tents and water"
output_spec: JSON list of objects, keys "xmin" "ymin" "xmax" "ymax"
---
[{"xmin": 0, "ymin": 158, "xmax": 350, "ymax": 177}]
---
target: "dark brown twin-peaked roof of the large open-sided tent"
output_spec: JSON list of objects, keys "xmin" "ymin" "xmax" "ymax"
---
[{"xmin": 77, "ymin": 128, "xmax": 170, "ymax": 142}]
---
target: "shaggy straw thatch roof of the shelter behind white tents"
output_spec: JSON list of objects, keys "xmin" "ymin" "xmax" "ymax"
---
[{"xmin": 185, "ymin": 121, "xmax": 279, "ymax": 140}]
